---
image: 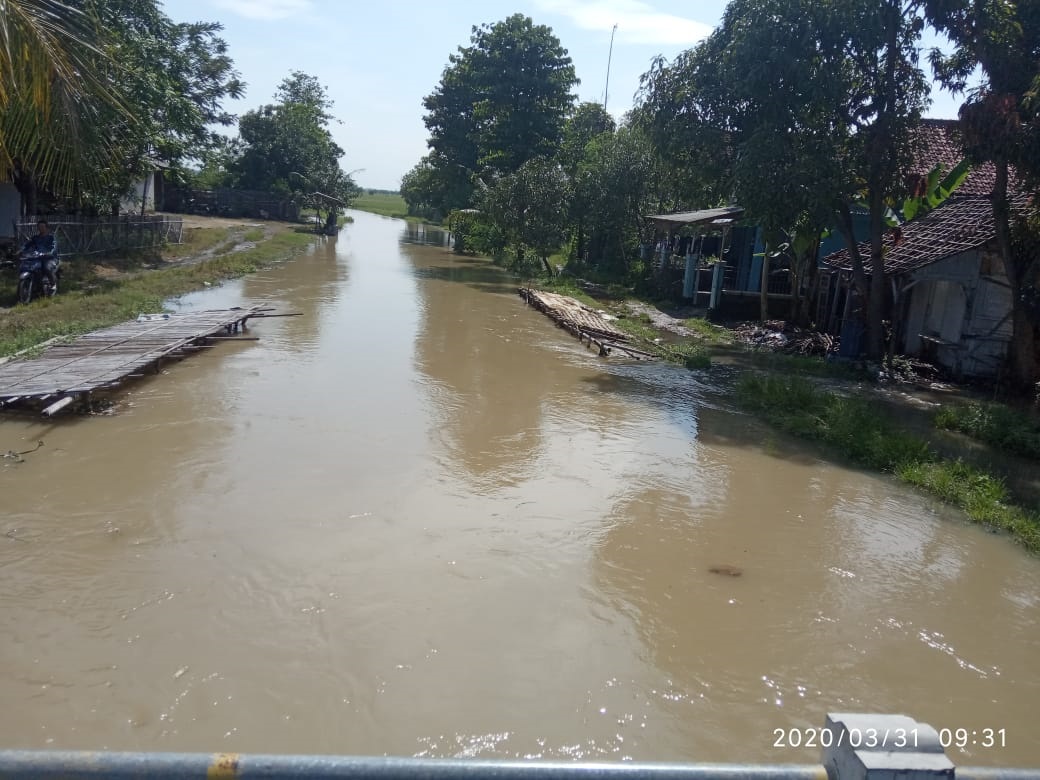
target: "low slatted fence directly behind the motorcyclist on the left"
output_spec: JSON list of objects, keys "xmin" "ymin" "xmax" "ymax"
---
[{"xmin": 15, "ymin": 214, "xmax": 184, "ymax": 257}]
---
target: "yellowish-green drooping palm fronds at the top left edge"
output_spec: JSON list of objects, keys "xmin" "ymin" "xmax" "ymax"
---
[{"xmin": 0, "ymin": 0, "xmax": 131, "ymax": 211}]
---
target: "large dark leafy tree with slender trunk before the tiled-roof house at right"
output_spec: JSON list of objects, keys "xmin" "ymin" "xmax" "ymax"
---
[{"xmin": 641, "ymin": 0, "xmax": 927, "ymax": 358}]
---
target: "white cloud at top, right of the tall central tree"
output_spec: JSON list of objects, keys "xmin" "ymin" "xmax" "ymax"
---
[{"xmin": 537, "ymin": 0, "xmax": 711, "ymax": 46}]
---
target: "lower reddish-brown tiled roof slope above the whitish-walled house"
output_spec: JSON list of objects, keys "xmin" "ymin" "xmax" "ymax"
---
[{"xmin": 823, "ymin": 194, "xmax": 1029, "ymax": 274}]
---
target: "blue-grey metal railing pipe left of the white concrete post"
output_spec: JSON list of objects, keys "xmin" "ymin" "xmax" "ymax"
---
[{"xmin": 0, "ymin": 751, "xmax": 832, "ymax": 780}]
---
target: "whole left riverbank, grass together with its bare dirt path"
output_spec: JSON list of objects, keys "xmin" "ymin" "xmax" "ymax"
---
[{"xmin": 0, "ymin": 217, "xmax": 314, "ymax": 358}]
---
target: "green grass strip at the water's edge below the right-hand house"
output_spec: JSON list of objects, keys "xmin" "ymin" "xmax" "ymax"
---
[{"xmin": 736, "ymin": 375, "xmax": 1040, "ymax": 553}]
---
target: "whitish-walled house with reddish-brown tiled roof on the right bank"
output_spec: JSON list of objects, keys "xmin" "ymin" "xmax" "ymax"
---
[{"xmin": 823, "ymin": 120, "xmax": 1030, "ymax": 378}]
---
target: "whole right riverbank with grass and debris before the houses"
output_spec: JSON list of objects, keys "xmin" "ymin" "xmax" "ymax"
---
[{"xmin": 524, "ymin": 278, "xmax": 1040, "ymax": 554}]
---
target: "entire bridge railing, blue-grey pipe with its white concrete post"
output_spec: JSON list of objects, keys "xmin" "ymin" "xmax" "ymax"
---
[{"xmin": 0, "ymin": 714, "xmax": 1040, "ymax": 780}]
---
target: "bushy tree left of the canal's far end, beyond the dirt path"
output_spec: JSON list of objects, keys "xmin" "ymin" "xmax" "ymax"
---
[{"xmin": 230, "ymin": 71, "xmax": 358, "ymax": 202}]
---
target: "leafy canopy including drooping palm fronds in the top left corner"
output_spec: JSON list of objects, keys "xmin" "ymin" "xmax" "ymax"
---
[{"xmin": 0, "ymin": 0, "xmax": 243, "ymax": 210}]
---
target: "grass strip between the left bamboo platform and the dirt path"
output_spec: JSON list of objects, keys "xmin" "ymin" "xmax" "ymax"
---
[{"xmin": 0, "ymin": 229, "xmax": 314, "ymax": 357}]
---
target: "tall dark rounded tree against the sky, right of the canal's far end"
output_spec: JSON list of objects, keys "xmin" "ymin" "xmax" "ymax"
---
[{"xmin": 413, "ymin": 14, "xmax": 578, "ymax": 213}]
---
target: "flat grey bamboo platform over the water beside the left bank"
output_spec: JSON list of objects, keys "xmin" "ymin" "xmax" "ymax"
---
[{"xmin": 0, "ymin": 306, "xmax": 291, "ymax": 417}]
